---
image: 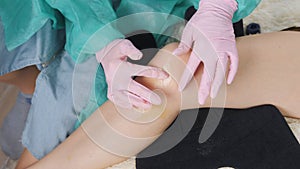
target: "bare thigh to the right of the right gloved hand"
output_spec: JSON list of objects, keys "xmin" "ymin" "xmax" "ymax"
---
[{"xmin": 233, "ymin": 32, "xmax": 300, "ymax": 118}]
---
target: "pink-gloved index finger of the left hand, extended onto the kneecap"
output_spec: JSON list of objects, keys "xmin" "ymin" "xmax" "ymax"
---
[{"xmin": 128, "ymin": 63, "xmax": 169, "ymax": 79}]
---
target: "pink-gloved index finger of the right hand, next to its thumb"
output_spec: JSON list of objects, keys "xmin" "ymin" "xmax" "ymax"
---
[{"xmin": 179, "ymin": 51, "xmax": 201, "ymax": 91}]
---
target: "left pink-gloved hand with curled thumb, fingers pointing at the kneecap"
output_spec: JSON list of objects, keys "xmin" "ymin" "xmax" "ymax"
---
[{"xmin": 96, "ymin": 39, "xmax": 169, "ymax": 109}]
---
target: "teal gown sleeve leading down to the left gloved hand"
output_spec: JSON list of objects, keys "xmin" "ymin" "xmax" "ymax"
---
[{"xmin": 46, "ymin": 0, "xmax": 124, "ymax": 62}]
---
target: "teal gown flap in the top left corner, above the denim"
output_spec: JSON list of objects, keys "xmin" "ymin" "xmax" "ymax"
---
[{"xmin": 0, "ymin": 0, "xmax": 64, "ymax": 50}]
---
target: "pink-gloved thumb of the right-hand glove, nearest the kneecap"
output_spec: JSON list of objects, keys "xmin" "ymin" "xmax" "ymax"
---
[{"xmin": 173, "ymin": 25, "xmax": 193, "ymax": 56}]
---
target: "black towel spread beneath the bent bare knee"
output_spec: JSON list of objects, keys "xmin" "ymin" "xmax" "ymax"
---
[{"xmin": 136, "ymin": 105, "xmax": 300, "ymax": 169}]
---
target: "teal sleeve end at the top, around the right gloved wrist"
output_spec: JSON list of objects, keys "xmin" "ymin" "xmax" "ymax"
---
[{"xmin": 192, "ymin": 0, "xmax": 261, "ymax": 23}]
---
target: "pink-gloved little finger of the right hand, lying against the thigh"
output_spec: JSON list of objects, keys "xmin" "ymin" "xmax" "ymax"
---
[{"xmin": 227, "ymin": 49, "xmax": 239, "ymax": 84}]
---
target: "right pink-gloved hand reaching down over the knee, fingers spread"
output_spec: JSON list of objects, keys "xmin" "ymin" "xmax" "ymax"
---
[{"xmin": 173, "ymin": 0, "xmax": 238, "ymax": 104}]
